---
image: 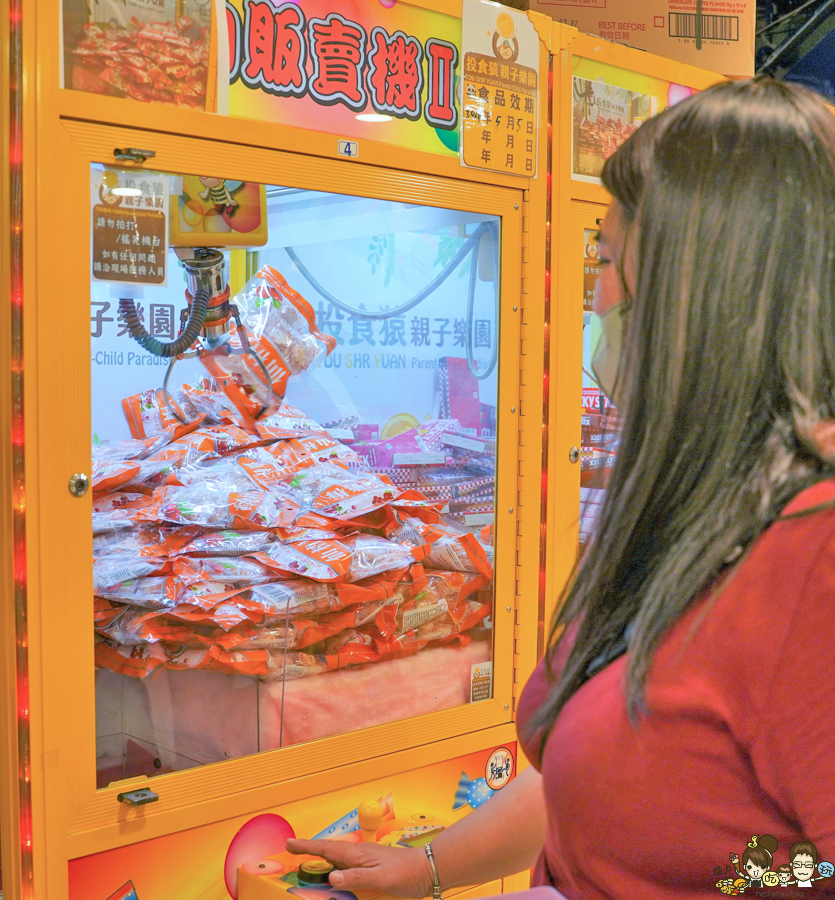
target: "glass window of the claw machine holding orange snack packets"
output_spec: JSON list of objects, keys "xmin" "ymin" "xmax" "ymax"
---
[{"xmin": 90, "ymin": 165, "xmax": 500, "ymax": 787}]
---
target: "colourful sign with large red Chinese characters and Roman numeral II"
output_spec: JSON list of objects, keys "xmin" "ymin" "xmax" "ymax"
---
[{"xmin": 225, "ymin": 0, "xmax": 461, "ymax": 158}]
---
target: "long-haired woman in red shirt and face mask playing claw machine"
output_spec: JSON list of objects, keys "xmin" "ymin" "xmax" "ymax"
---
[{"xmin": 290, "ymin": 80, "xmax": 835, "ymax": 900}]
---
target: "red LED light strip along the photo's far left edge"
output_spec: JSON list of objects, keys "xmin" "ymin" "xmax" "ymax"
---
[{"xmin": 9, "ymin": 0, "xmax": 34, "ymax": 900}]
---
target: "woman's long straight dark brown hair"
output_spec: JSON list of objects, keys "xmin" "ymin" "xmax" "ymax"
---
[{"xmin": 529, "ymin": 80, "xmax": 835, "ymax": 747}]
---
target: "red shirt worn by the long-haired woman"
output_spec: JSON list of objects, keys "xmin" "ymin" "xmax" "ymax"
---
[{"xmin": 519, "ymin": 482, "xmax": 835, "ymax": 900}]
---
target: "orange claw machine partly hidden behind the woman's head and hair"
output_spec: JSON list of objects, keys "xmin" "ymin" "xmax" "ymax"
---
[{"xmin": 543, "ymin": 29, "xmax": 724, "ymax": 623}]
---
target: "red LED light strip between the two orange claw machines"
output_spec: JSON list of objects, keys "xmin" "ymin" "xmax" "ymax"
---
[{"xmin": 536, "ymin": 56, "xmax": 554, "ymax": 659}]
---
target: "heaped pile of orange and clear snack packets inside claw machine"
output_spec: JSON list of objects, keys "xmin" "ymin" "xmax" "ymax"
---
[{"xmin": 93, "ymin": 278, "xmax": 493, "ymax": 680}]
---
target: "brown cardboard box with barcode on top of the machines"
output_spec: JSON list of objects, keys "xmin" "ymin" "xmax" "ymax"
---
[{"xmin": 528, "ymin": 0, "xmax": 757, "ymax": 78}]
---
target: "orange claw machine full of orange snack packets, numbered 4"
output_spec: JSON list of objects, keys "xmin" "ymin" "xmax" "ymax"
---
[{"xmin": 0, "ymin": 0, "xmax": 568, "ymax": 900}]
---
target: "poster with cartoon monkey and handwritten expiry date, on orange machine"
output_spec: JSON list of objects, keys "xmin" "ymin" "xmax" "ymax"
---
[{"xmin": 461, "ymin": 0, "xmax": 539, "ymax": 178}]
